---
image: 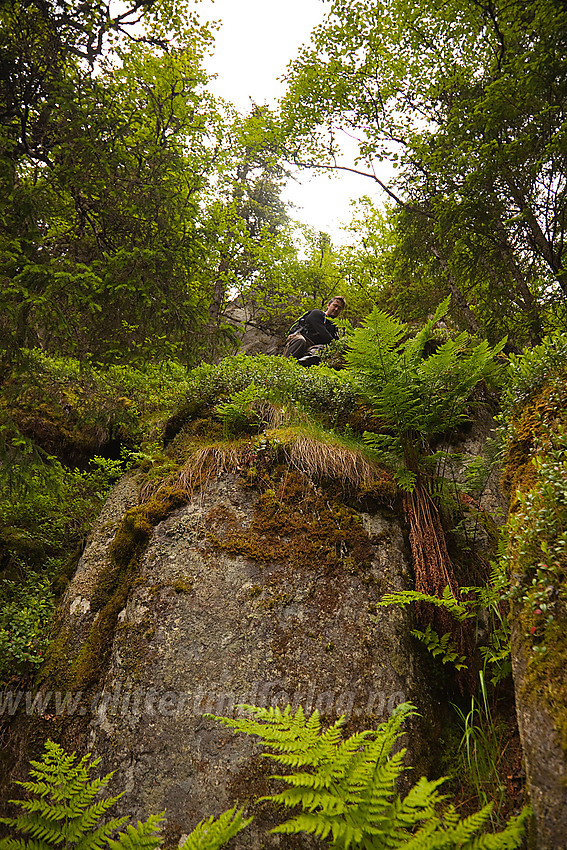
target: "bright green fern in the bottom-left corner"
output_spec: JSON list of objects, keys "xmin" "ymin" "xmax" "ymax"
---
[{"xmin": 0, "ymin": 741, "xmax": 163, "ymax": 850}]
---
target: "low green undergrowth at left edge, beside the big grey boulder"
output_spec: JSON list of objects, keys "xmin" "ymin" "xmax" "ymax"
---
[{"xmin": 0, "ymin": 458, "xmax": 127, "ymax": 684}]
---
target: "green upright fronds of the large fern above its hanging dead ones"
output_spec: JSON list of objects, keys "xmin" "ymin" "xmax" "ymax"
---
[{"xmin": 347, "ymin": 299, "xmax": 504, "ymax": 484}]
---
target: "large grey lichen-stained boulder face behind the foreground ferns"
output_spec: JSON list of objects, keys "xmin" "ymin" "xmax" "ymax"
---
[{"xmin": 57, "ymin": 470, "xmax": 431, "ymax": 848}]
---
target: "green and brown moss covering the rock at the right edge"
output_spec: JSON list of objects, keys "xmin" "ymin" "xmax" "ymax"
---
[{"xmin": 503, "ymin": 378, "xmax": 567, "ymax": 753}]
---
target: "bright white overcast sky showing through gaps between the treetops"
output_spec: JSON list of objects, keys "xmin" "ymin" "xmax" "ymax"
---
[{"xmin": 199, "ymin": 0, "xmax": 380, "ymax": 243}]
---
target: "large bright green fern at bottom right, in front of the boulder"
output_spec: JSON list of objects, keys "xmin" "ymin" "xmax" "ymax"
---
[{"xmin": 211, "ymin": 703, "xmax": 528, "ymax": 850}]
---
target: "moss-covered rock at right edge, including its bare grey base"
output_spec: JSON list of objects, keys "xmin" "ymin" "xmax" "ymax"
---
[{"xmin": 503, "ymin": 375, "xmax": 567, "ymax": 850}]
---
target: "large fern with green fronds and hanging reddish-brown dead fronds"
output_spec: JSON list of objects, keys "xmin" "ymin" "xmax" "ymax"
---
[{"xmin": 347, "ymin": 298, "xmax": 505, "ymax": 642}]
